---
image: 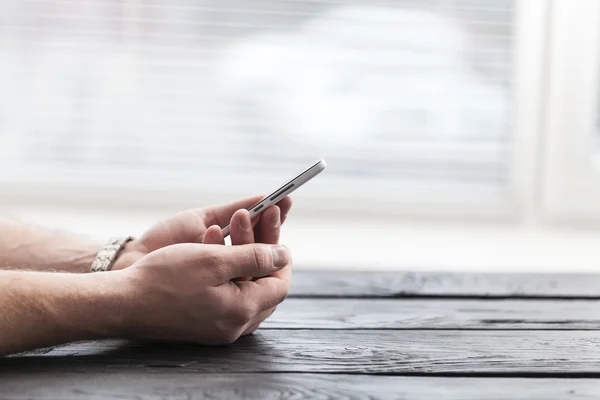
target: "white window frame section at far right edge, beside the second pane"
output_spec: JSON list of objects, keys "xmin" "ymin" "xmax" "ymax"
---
[{"xmin": 541, "ymin": 0, "xmax": 600, "ymax": 222}]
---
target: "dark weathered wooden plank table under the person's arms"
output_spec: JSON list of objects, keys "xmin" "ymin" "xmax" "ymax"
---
[{"xmin": 0, "ymin": 270, "xmax": 600, "ymax": 400}]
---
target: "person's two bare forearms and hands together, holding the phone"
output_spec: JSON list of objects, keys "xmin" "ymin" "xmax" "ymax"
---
[{"xmin": 0, "ymin": 197, "xmax": 291, "ymax": 356}]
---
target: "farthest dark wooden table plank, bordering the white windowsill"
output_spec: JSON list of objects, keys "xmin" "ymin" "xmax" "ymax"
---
[{"xmin": 291, "ymin": 269, "xmax": 600, "ymax": 298}]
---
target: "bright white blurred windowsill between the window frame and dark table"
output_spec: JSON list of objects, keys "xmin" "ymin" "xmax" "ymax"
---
[{"xmin": 7, "ymin": 207, "xmax": 600, "ymax": 272}]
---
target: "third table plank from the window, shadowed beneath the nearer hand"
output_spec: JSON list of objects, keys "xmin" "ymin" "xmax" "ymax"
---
[{"xmin": 7, "ymin": 329, "xmax": 600, "ymax": 376}]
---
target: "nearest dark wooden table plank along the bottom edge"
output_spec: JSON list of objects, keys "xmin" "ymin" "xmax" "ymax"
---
[{"xmin": 0, "ymin": 371, "xmax": 600, "ymax": 400}]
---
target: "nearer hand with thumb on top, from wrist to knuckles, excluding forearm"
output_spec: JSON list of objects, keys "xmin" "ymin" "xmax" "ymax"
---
[{"xmin": 120, "ymin": 243, "xmax": 291, "ymax": 344}]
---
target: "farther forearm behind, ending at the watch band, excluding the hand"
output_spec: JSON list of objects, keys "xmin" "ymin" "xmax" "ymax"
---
[{"xmin": 0, "ymin": 217, "xmax": 102, "ymax": 273}]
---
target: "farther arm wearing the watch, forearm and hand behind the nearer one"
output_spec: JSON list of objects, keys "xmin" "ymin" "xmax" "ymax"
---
[{"xmin": 0, "ymin": 196, "xmax": 292, "ymax": 273}]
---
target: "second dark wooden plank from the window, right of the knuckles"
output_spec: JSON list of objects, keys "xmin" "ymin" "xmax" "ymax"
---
[{"xmin": 263, "ymin": 298, "xmax": 600, "ymax": 329}]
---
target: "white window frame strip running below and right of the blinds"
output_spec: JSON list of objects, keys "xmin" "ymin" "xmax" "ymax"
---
[{"xmin": 0, "ymin": 0, "xmax": 548, "ymax": 220}]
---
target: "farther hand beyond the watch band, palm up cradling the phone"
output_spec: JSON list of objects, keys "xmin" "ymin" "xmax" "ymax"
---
[{"xmin": 112, "ymin": 196, "xmax": 292, "ymax": 270}]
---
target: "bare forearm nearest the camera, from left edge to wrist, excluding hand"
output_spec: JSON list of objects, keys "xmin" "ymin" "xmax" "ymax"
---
[{"xmin": 0, "ymin": 271, "xmax": 129, "ymax": 356}]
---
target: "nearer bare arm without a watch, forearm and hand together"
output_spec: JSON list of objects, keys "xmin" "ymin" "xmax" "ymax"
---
[{"xmin": 0, "ymin": 239, "xmax": 292, "ymax": 356}]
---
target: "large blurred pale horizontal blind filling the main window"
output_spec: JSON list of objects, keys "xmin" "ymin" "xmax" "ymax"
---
[{"xmin": 0, "ymin": 0, "xmax": 515, "ymax": 199}]
